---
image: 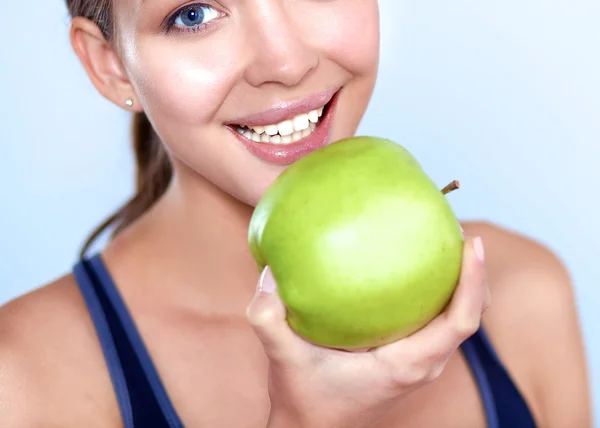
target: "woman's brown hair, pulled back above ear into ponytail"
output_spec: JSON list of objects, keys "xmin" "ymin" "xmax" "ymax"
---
[{"xmin": 66, "ymin": 0, "xmax": 173, "ymax": 257}]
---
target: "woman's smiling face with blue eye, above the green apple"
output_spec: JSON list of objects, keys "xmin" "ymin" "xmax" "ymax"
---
[{"xmin": 114, "ymin": 0, "xmax": 379, "ymax": 205}]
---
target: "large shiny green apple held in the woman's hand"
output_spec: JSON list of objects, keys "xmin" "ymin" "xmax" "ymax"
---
[{"xmin": 248, "ymin": 137, "xmax": 463, "ymax": 350}]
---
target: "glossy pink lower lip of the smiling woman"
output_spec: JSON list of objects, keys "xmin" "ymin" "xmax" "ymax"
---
[{"xmin": 229, "ymin": 92, "xmax": 339, "ymax": 166}]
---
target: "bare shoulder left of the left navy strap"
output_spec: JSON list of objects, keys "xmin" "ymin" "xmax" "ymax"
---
[{"xmin": 0, "ymin": 275, "xmax": 118, "ymax": 428}]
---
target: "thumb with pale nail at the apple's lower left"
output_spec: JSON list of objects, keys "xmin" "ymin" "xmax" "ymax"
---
[{"xmin": 246, "ymin": 266, "xmax": 296, "ymax": 360}]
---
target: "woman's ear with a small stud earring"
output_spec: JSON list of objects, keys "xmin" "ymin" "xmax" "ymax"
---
[{"xmin": 69, "ymin": 16, "xmax": 142, "ymax": 112}]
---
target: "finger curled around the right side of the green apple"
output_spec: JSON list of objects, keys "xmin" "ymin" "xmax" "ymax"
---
[{"xmin": 374, "ymin": 238, "xmax": 487, "ymax": 361}]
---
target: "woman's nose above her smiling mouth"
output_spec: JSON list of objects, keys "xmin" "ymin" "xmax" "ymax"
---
[{"xmin": 244, "ymin": 5, "xmax": 319, "ymax": 87}]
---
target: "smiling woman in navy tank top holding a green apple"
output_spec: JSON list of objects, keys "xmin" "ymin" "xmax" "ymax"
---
[{"xmin": 0, "ymin": 0, "xmax": 591, "ymax": 428}]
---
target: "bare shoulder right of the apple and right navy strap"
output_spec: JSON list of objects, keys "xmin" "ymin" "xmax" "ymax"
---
[{"xmin": 464, "ymin": 223, "xmax": 591, "ymax": 427}]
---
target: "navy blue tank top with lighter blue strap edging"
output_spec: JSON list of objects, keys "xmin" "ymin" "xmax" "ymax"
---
[{"xmin": 73, "ymin": 254, "xmax": 536, "ymax": 428}]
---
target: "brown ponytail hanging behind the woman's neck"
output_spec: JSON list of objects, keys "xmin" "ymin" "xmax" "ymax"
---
[{"xmin": 80, "ymin": 113, "xmax": 173, "ymax": 258}]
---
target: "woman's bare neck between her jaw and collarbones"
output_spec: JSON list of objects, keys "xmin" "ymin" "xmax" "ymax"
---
[{"xmin": 105, "ymin": 164, "xmax": 259, "ymax": 313}]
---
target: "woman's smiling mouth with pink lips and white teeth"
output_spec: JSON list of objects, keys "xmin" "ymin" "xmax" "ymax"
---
[{"xmin": 229, "ymin": 90, "xmax": 338, "ymax": 165}]
